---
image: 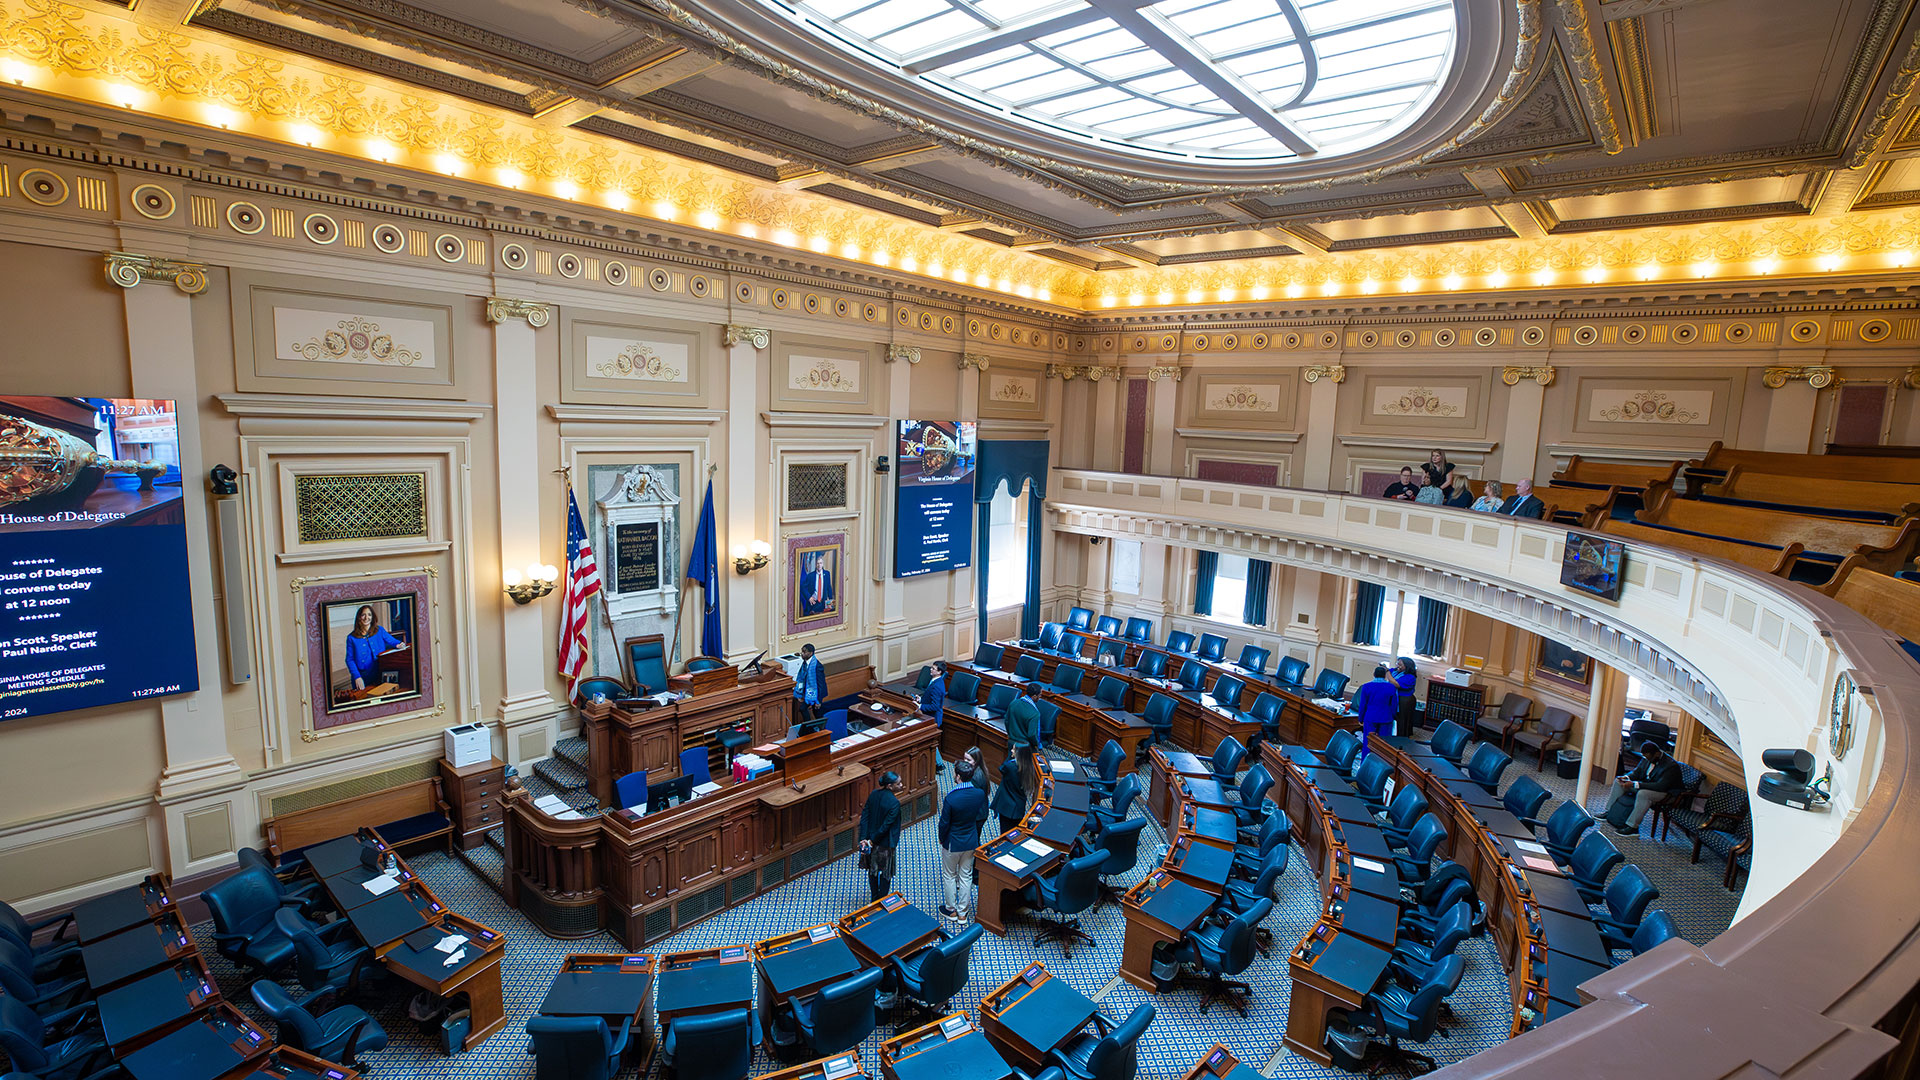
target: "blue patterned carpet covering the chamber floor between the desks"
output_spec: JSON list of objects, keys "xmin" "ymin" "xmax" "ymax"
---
[{"xmin": 194, "ymin": 726, "xmax": 1738, "ymax": 1080}]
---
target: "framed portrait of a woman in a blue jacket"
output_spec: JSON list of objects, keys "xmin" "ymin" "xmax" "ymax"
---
[{"xmin": 298, "ymin": 567, "xmax": 444, "ymax": 740}]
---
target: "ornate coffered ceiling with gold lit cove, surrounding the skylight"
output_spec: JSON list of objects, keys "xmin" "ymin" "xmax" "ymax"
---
[{"xmin": 0, "ymin": 0, "xmax": 1920, "ymax": 309}]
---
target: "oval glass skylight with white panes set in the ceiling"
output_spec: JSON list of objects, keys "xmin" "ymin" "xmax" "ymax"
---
[{"xmin": 756, "ymin": 0, "xmax": 1457, "ymax": 165}]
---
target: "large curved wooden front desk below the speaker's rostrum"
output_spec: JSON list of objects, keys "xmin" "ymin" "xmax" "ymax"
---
[{"xmin": 501, "ymin": 707, "xmax": 939, "ymax": 949}]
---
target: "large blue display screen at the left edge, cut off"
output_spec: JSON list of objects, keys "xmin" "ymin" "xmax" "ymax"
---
[{"xmin": 0, "ymin": 398, "xmax": 200, "ymax": 719}]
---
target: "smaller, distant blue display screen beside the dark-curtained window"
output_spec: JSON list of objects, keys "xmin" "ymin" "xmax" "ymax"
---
[{"xmin": 893, "ymin": 421, "xmax": 979, "ymax": 578}]
